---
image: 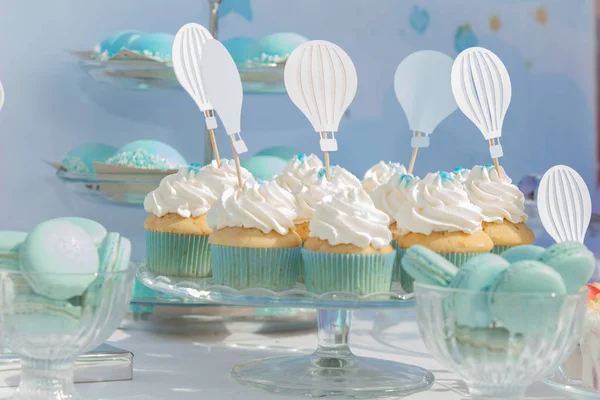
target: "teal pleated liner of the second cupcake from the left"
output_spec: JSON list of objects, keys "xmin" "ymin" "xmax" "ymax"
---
[{"xmin": 211, "ymin": 244, "xmax": 302, "ymax": 291}]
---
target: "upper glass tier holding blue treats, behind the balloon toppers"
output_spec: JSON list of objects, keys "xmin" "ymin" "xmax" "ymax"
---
[{"xmin": 70, "ymin": 51, "xmax": 285, "ymax": 94}]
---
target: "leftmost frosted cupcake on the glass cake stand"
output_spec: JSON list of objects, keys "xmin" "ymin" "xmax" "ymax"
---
[{"xmin": 144, "ymin": 167, "xmax": 219, "ymax": 278}]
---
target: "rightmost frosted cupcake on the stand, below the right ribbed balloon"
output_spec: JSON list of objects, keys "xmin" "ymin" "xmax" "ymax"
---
[{"xmin": 465, "ymin": 165, "xmax": 535, "ymax": 254}]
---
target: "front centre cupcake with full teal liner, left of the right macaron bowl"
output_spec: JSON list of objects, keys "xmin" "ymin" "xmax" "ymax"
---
[{"xmin": 302, "ymin": 189, "xmax": 396, "ymax": 295}]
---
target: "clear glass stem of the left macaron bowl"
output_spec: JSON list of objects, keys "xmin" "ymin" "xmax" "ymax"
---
[{"xmin": 18, "ymin": 359, "xmax": 75, "ymax": 400}]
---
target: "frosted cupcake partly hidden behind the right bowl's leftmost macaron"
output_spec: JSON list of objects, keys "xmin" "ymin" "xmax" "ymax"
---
[{"xmin": 394, "ymin": 172, "xmax": 494, "ymax": 291}]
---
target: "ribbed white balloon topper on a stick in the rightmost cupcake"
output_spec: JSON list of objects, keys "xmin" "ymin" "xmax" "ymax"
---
[{"xmin": 452, "ymin": 47, "xmax": 512, "ymax": 173}]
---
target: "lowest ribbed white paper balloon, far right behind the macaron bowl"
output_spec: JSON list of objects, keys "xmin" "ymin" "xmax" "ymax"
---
[{"xmin": 537, "ymin": 165, "xmax": 592, "ymax": 243}]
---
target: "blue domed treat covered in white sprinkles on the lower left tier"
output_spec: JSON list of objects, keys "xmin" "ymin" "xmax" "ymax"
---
[{"xmin": 106, "ymin": 140, "xmax": 187, "ymax": 170}]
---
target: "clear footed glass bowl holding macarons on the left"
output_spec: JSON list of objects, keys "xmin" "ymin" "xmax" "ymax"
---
[{"xmin": 0, "ymin": 264, "xmax": 136, "ymax": 400}]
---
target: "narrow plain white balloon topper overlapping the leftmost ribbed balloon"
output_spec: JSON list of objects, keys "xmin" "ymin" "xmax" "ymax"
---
[{"xmin": 201, "ymin": 39, "xmax": 248, "ymax": 187}]
